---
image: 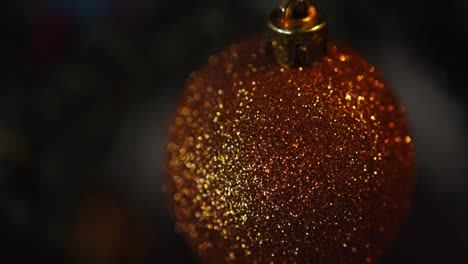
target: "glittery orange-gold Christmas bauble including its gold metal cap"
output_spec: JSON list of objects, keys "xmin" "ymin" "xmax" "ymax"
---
[{"xmin": 165, "ymin": 0, "xmax": 414, "ymax": 263}]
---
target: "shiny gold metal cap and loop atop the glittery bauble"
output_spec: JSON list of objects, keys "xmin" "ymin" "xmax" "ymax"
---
[{"xmin": 268, "ymin": 0, "xmax": 327, "ymax": 68}]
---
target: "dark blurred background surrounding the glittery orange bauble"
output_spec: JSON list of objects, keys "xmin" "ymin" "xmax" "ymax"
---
[{"xmin": 0, "ymin": 0, "xmax": 468, "ymax": 263}]
